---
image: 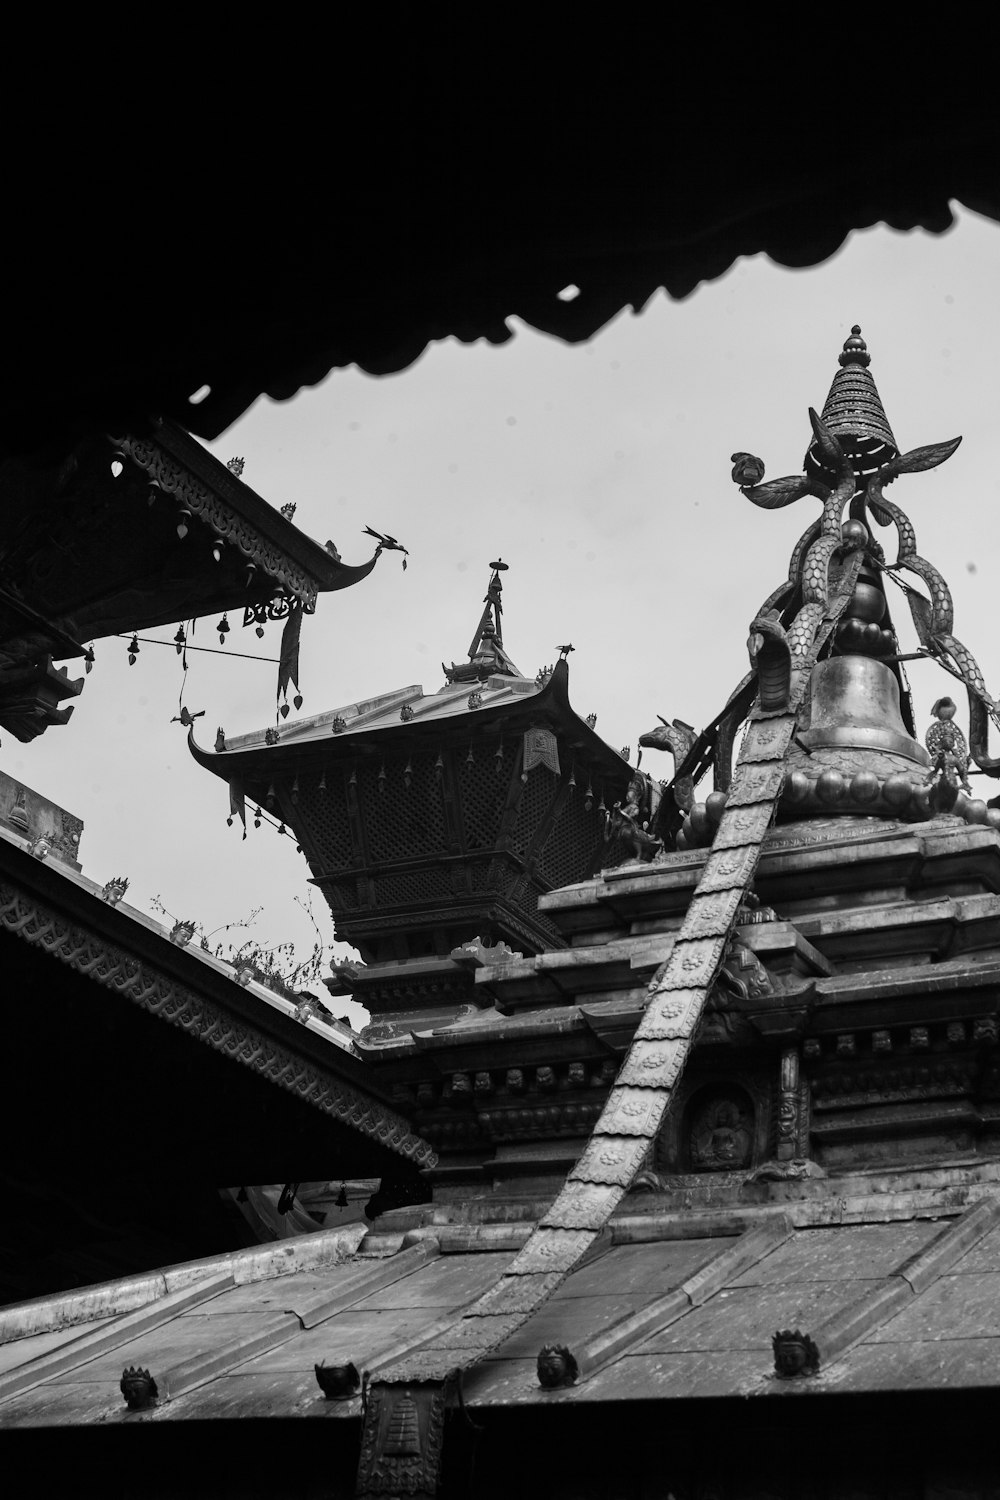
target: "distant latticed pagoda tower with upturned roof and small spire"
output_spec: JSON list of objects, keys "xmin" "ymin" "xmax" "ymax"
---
[{"xmin": 190, "ymin": 560, "xmax": 631, "ymax": 1038}]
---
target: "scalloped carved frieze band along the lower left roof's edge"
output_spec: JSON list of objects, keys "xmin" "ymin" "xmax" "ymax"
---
[{"xmin": 0, "ymin": 885, "xmax": 436, "ymax": 1167}]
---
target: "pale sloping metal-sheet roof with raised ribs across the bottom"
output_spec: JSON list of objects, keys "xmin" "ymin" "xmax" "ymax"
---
[{"xmin": 0, "ymin": 1188, "xmax": 1000, "ymax": 1446}]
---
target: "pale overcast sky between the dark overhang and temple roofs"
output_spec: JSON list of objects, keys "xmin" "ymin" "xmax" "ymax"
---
[{"xmin": 7, "ymin": 213, "xmax": 1000, "ymax": 1026}]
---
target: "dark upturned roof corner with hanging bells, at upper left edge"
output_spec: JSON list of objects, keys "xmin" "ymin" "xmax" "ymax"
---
[{"xmin": 0, "ymin": 420, "xmax": 378, "ymax": 741}]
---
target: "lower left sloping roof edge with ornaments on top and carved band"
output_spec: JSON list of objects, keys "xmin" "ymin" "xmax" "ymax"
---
[{"xmin": 0, "ymin": 828, "xmax": 433, "ymax": 1166}]
